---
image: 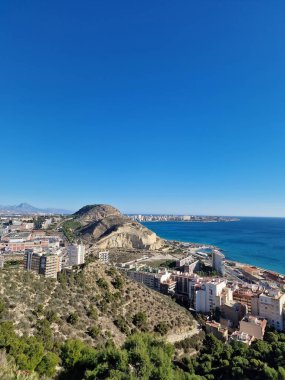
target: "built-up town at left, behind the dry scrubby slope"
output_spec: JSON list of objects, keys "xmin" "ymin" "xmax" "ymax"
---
[{"xmin": 0, "ymin": 216, "xmax": 85, "ymax": 278}]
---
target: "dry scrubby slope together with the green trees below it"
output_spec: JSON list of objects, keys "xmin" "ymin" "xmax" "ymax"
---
[{"xmin": 0, "ymin": 262, "xmax": 285, "ymax": 380}]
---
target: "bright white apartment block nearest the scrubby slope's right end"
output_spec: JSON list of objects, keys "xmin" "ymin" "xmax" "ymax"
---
[{"xmin": 194, "ymin": 278, "xmax": 227, "ymax": 313}]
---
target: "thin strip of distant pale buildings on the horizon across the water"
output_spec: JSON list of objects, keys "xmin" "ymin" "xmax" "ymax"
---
[{"xmin": 127, "ymin": 214, "xmax": 239, "ymax": 223}]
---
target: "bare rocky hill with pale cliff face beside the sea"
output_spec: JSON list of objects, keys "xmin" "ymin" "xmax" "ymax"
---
[{"xmin": 74, "ymin": 205, "xmax": 164, "ymax": 250}]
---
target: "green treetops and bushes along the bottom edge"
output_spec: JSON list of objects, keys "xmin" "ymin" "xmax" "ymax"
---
[{"xmin": 0, "ymin": 322, "xmax": 285, "ymax": 380}]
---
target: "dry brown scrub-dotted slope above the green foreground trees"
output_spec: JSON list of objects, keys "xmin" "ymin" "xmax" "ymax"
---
[{"xmin": 0, "ymin": 261, "xmax": 193, "ymax": 346}]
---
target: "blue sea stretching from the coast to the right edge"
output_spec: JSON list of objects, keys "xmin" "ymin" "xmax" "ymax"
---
[{"xmin": 143, "ymin": 218, "xmax": 285, "ymax": 274}]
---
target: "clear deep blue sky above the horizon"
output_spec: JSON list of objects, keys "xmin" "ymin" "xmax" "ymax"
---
[{"xmin": 0, "ymin": 0, "xmax": 285, "ymax": 216}]
